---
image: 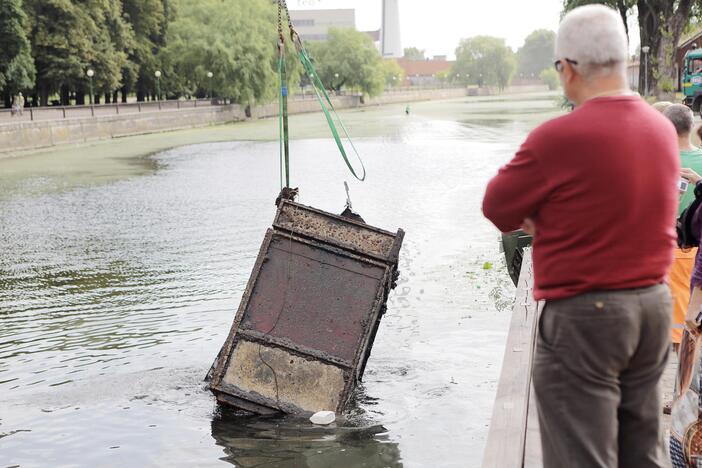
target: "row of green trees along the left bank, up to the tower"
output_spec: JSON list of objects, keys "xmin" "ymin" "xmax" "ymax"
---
[{"xmin": 0, "ymin": 0, "xmax": 402, "ymax": 107}]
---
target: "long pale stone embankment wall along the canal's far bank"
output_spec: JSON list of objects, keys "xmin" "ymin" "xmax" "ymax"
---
[{"xmin": 0, "ymin": 88, "xmax": 478, "ymax": 153}]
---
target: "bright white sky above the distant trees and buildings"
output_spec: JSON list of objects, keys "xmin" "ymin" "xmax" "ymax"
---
[{"xmin": 288, "ymin": 0, "xmax": 563, "ymax": 58}]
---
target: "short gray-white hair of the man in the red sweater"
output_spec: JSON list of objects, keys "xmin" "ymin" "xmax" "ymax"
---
[{"xmin": 556, "ymin": 5, "xmax": 629, "ymax": 78}]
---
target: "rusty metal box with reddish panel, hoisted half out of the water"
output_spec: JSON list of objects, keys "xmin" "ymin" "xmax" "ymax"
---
[{"xmin": 210, "ymin": 198, "xmax": 404, "ymax": 414}]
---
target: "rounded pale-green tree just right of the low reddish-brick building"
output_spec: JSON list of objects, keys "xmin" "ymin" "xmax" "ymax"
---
[{"xmin": 453, "ymin": 36, "xmax": 516, "ymax": 91}]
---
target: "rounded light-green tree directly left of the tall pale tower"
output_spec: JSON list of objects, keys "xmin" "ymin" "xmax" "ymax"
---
[{"xmin": 309, "ymin": 28, "xmax": 385, "ymax": 96}]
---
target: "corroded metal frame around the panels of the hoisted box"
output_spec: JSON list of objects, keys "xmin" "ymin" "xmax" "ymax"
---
[{"xmin": 209, "ymin": 200, "xmax": 404, "ymax": 414}]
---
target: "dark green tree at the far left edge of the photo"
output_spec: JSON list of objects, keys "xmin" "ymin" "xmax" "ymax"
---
[{"xmin": 0, "ymin": 0, "xmax": 36, "ymax": 106}]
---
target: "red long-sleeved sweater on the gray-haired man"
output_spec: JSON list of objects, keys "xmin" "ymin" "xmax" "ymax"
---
[{"xmin": 483, "ymin": 96, "xmax": 680, "ymax": 300}]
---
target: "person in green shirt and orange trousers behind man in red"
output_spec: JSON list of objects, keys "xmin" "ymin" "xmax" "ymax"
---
[{"xmin": 663, "ymin": 104, "xmax": 702, "ymax": 351}]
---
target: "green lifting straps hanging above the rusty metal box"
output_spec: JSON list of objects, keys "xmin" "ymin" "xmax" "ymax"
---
[{"xmin": 278, "ymin": 0, "xmax": 366, "ymax": 188}]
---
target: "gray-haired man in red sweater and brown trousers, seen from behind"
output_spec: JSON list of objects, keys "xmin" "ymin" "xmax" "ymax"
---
[{"xmin": 483, "ymin": 5, "xmax": 680, "ymax": 468}]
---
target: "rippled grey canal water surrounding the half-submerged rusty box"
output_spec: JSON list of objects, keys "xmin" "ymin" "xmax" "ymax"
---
[{"xmin": 0, "ymin": 96, "xmax": 557, "ymax": 468}]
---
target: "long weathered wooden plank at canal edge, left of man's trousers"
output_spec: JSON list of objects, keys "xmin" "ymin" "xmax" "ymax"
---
[{"xmin": 483, "ymin": 249, "xmax": 538, "ymax": 468}]
